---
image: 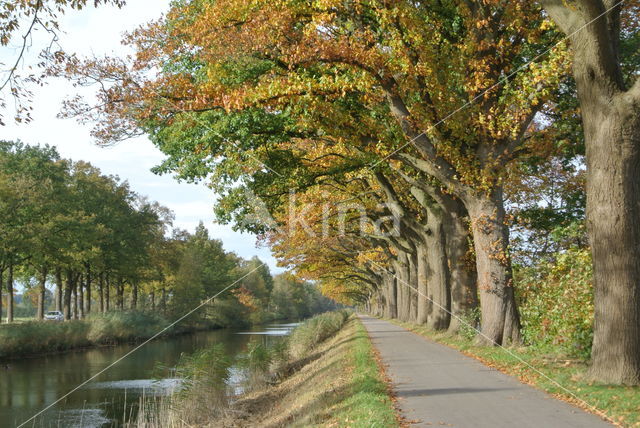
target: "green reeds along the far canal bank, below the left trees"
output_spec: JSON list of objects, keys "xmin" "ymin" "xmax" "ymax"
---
[{"xmin": 0, "ymin": 312, "xmax": 168, "ymax": 358}]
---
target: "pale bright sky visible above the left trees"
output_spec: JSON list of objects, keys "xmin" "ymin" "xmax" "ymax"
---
[{"xmin": 0, "ymin": 0, "xmax": 282, "ymax": 272}]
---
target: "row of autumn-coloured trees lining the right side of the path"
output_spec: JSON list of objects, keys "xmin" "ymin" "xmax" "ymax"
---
[{"xmin": 52, "ymin": 0, "xmax": 640, "ymax": 384}]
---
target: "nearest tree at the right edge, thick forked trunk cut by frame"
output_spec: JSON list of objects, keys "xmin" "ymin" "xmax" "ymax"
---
[{"xmin": 540, "ymin": 0, "xmax": 640, "ymax": 385}]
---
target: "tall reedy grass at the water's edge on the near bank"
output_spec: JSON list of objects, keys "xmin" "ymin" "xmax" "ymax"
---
[{"xmin": 131, "ymin": 310, "xmax": 350, "ymax": 428}]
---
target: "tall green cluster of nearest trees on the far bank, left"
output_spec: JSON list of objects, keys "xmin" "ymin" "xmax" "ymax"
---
[{"xmin": 0, "ymin": 141, "xmax": 170, "ymax": 322}]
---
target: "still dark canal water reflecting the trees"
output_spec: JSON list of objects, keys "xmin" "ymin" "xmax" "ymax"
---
[{"xmin": 0, "ymin": 324, "xmax": 296, "ymax": 428}]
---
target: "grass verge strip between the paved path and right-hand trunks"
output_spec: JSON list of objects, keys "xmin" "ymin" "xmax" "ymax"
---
[{"xmin": 390, "ymin": 320, "xmax": 640, "ymax": 427}]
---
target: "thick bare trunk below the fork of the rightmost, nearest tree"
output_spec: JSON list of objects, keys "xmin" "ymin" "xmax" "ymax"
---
[{"xmin": 578, "ymin": 88, "xmax": 640, "ymax": 385}]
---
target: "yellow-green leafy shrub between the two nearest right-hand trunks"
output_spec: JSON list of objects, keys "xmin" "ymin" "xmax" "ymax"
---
[{"xmin": 515, "ymin": 248, "xmax": 594, "ymax": 359}]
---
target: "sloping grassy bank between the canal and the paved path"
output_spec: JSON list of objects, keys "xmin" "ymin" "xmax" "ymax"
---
[{"xmin": 138, "ymin": 312, "xmax": 398, "ymax": 428}]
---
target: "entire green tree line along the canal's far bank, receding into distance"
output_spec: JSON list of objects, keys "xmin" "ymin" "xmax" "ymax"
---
[{"xmin": 0, "ymin": 141, "xmax": 336, "ymax": 325}]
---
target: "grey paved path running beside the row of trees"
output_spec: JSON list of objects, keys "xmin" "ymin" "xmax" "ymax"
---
[{"xmin": 360, "ymin": 316, "xmax": 612, "ymax": 428}]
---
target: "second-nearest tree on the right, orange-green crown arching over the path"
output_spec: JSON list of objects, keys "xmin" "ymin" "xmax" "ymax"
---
[{"xmin": 65, "ymin": 0, "xmax": 565, "ymax": 343}]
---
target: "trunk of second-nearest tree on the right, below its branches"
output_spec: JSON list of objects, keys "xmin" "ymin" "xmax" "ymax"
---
[{"xmin": 466, "ymin": 188, "xmax": 521, "ymax": 345}]
